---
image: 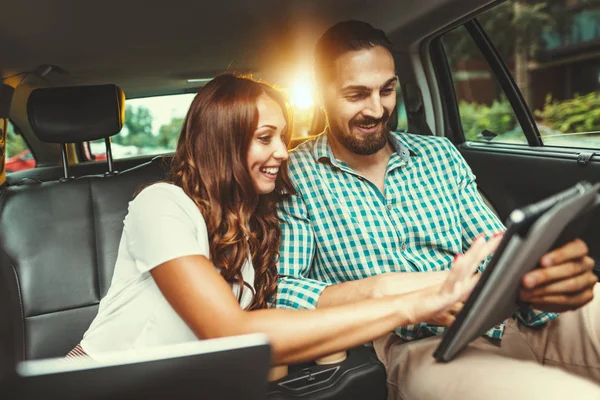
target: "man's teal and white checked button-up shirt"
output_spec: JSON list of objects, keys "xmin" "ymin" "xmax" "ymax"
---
[{"xmin": 275, "ymin": 133, "xmax": 555, "ymax": 340}]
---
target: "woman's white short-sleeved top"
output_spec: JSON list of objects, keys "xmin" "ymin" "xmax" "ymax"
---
[{"xmin": 81, "ymin": 183, "xmax": 254, "ymax": 360}]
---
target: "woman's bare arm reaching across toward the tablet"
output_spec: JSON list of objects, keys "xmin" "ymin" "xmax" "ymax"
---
[{"xmin": 151, "ymin": 233, "xmax": 499, "ymax": 364}]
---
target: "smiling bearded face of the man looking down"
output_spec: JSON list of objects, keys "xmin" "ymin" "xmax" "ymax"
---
[{"xmin": 322, "ymin": 46, "xmax": 397, "ymax": 155}]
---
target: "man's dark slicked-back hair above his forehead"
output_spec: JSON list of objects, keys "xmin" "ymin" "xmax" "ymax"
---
[{"xmin": 314, "ymin": 21, "xmax": 392, "ymax": 85}]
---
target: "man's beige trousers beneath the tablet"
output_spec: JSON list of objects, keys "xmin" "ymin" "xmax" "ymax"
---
[{"xmin": 373, "ymin": 284, "xmax": 600, "ymax": 400}]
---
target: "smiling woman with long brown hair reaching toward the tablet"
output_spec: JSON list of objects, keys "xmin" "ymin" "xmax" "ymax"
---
[{"xmin": 70, "ymin": 74, "xmax": 499, "ymax": 364}]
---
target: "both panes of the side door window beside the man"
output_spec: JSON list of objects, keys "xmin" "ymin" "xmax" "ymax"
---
[{"xmin": 443, "ymin": 0, "xmax": 600, "ymax": 148}]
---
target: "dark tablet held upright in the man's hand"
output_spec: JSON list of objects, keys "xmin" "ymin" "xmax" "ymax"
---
[{"xmin": 433, "ymin": 182, "xmax": 600, "ymax": 361}]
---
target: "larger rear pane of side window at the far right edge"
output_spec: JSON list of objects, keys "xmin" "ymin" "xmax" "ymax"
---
[{"xmin": 479, "ymin": 0, "xmax": 600, "ymax": 148}]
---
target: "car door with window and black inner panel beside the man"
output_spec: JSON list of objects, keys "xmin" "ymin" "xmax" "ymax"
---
[{"xmin": 429, "ymin": 1, "xmax": 600, "ymax": 266}]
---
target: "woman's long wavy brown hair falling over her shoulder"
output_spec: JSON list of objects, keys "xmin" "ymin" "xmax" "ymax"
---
[{"xmin": 170, "ymin": 74, "xmax": 295, "ymax": 309}]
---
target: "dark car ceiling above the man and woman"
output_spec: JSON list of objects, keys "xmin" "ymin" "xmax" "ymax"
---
[{"xmin": 0, "ymin": 0, "xmax": 491, "ymax": 97}]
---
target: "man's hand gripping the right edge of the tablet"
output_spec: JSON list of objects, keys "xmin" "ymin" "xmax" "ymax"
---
[{"xmin": 519, "ymin": 239, "xmax": 598, "ymax": 312}]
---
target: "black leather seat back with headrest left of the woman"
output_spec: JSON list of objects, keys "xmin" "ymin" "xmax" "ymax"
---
[{"xmin": 0, "ymin": 85, "xmax": 168, "ymax": 361}]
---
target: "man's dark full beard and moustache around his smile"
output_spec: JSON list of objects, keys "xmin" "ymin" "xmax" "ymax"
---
[{"xmin": 329, "ymin": 111, "xmax": 390, "ymax": 156}]
